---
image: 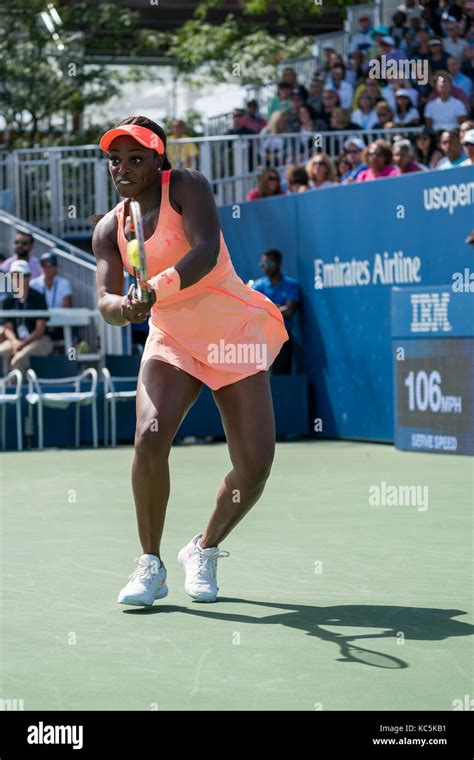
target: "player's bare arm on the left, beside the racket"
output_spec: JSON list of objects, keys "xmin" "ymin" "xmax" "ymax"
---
[{"xmin": 92, "ymin": 211, "xmax": 128, "ymax": 326}]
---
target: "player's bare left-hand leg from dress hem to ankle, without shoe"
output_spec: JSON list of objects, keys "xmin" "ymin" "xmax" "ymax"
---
[{"xmin": 132, "ymin": 359, "xmax": 202, "ymax": 557}]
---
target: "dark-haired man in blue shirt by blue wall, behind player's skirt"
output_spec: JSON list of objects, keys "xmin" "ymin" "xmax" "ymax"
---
[{"xmin": 252, "ymin": 248, "xmax": 301, "ymax": 375}]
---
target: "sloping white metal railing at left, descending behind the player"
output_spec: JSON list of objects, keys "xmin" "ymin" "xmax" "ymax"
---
[{"xmin": 0, "ymin": 210, "xmax": 130, "ymax": 355}]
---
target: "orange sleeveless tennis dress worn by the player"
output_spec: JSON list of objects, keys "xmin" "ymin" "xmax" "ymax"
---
[{"xmin": 116, "ymin": 169, "xmax": 288, "ymax": 390}]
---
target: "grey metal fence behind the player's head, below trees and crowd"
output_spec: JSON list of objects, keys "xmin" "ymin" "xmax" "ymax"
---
[{"xmin": 0, "ymin": 128, "xmax": 420, "ymax": 232}]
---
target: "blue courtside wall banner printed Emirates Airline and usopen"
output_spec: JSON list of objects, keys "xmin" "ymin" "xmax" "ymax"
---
[{"xmin": 221, "ymin": 167, "xmax": 474, "ymax": 441}]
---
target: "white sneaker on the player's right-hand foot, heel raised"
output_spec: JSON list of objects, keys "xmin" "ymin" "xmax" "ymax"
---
[{"xmin": 178, "ymin": 533, "xmax": 230, "ymax": 602}]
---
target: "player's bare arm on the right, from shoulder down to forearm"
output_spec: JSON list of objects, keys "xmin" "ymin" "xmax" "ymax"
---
[{"xmin": 170, "ymin": 169, "xmax": 220, "ymax": 290}]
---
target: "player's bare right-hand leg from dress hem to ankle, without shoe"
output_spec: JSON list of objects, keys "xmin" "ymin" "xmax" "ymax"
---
[{"xmin": 200, "ymin": 372, "xmax": 275, "ymax": 549}]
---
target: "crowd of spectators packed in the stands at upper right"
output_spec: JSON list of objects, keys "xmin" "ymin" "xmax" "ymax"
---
[{"xmin": 219, "ymin": 0, "xmax": 474, "ymax": 200}]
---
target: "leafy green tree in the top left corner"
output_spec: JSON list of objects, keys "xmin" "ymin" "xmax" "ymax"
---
[{"xmin": 0, "ymin": 0, "xmax": 150, "ymax": 147}]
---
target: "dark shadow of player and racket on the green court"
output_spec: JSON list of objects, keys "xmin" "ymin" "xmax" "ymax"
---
[{"xmin": 127, "ymin": 597, "xmax": 474, "ymax": 669}]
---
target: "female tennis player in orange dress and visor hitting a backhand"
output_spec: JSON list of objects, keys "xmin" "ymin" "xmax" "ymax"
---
[{"xmin": 93, "ymin": 116, "xmax": 288, "ymax": 605}]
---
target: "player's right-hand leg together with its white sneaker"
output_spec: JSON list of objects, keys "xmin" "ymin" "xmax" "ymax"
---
[{"xmin": 178, "ymin": 372, "xmax": 275, "ymax": 602}]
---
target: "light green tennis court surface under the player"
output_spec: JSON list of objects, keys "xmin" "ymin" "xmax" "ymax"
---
[{"xmin": 0, "ymin": 441, "xmax": 474, "ymax": 710}]
